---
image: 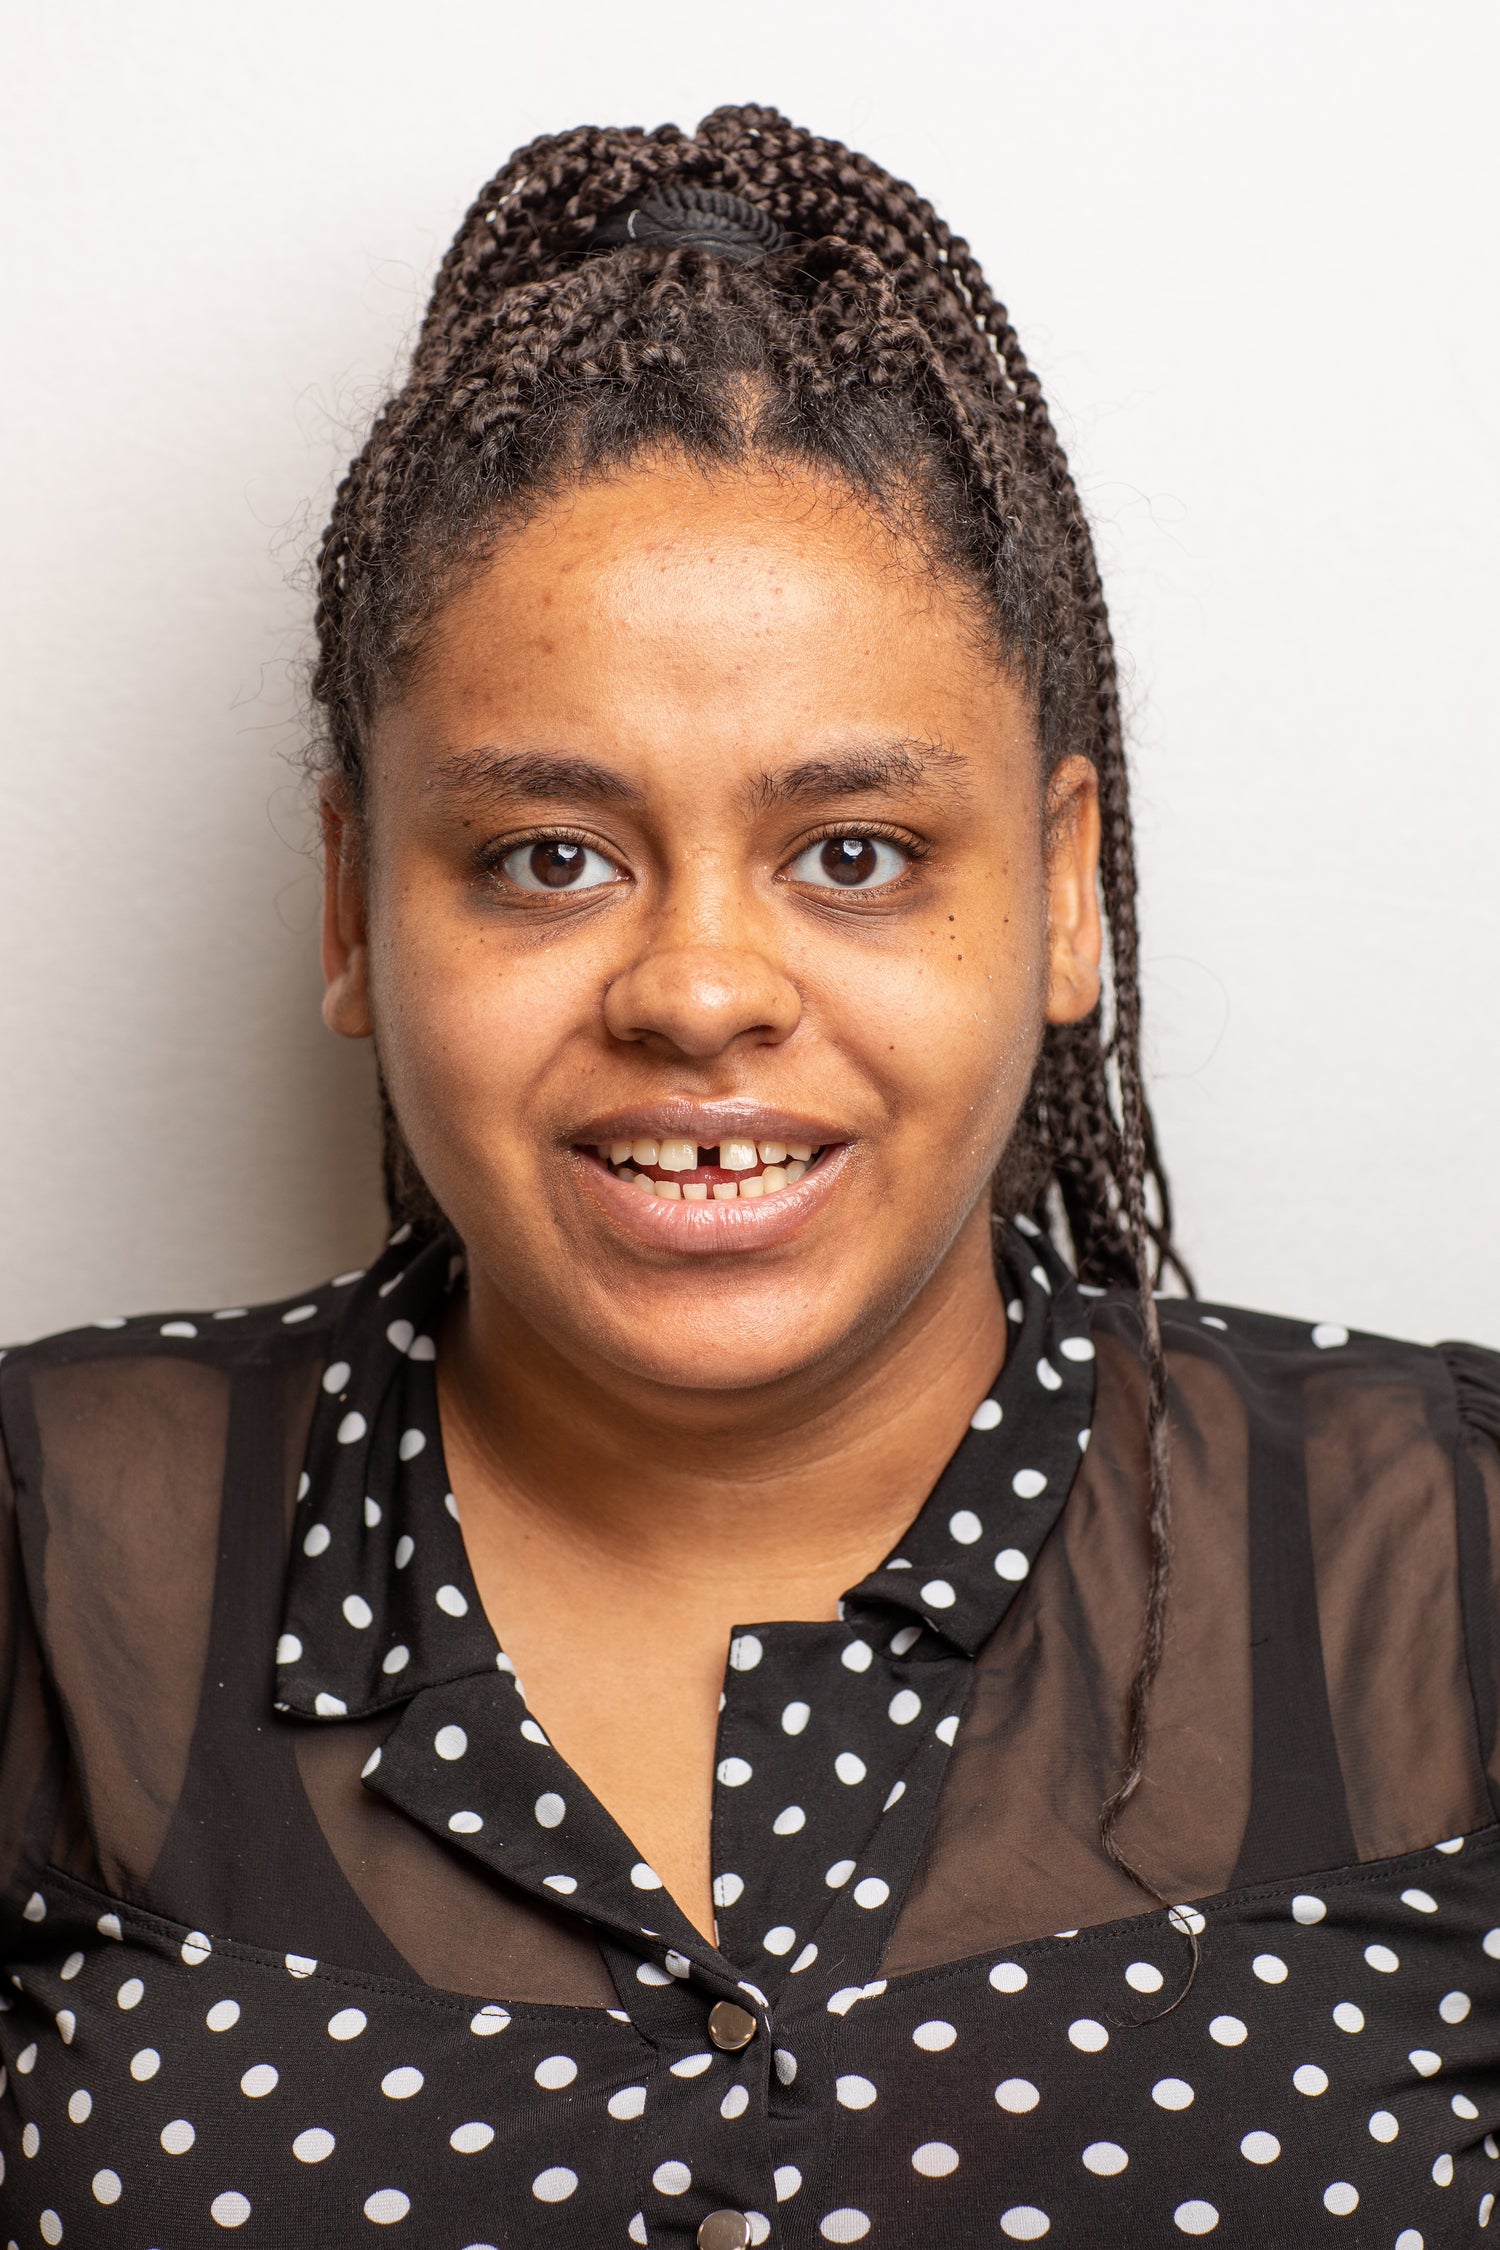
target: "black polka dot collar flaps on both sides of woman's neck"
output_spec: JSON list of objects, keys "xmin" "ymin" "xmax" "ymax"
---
[{"xmin": 277, "ymin": 1220, "xmax": 1093, "ymax": 1719}]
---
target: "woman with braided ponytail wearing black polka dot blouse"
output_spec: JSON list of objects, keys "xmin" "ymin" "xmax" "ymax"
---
[{"xmin": 0, "ymin": 108, "xmax": 1500, "ymax": 2250}]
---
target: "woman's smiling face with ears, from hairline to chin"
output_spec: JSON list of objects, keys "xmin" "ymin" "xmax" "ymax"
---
[{"xmin": 326, "ymin": 464, "xmax": 1100, "ymax": 1391}]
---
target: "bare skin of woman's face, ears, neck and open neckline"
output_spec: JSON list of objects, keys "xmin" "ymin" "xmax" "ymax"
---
[{"xmin": 324, "ymin": 459, "xmax": 1100, "ymax": 1935}]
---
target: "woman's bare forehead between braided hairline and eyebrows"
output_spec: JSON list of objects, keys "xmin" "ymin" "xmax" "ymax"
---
[{"xmin": 376, "ymin": 461, "xmax": 1030, "ymax": 796}]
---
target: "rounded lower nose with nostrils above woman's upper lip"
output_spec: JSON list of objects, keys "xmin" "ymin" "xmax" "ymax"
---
[{"xmin": 605, "ymin": 943, "xmax": 803, "ymax": 1060}]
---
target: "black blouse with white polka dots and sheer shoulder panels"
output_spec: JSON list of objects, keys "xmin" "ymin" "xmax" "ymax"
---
[{"xmin": 0, "ymin": 1231, "xmax": 1500, "ymax": 2250}]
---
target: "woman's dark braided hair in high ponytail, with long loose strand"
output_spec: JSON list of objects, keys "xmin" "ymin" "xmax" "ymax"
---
[{"xmin": 313, "ymin": 106, "xmax": 1187, "ymax": 1897}]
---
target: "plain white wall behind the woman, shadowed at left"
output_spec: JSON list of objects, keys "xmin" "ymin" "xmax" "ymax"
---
[{"xmin": 0, "ymin": 0, "xmax": 1500, "ymax": 1343}]
